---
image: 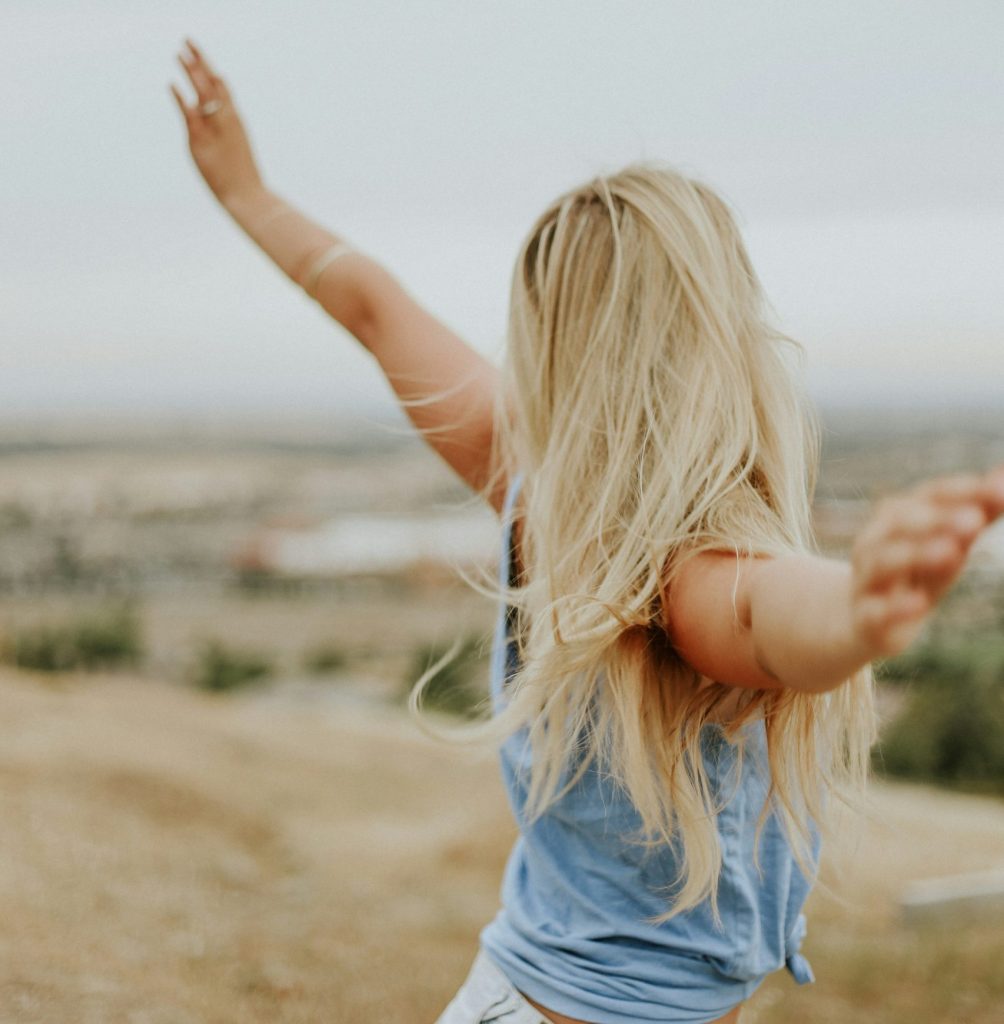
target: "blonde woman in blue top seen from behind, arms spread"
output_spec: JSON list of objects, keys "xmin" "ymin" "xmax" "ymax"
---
[{"xmin": 171, "ymin": 42, "xmax": 1004, "ymax": 1024}]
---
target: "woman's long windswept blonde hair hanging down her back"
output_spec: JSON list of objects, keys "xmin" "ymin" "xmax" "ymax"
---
[{"xmin": 413, "ymin": 163, "xmax": 875, "ymax": 920}]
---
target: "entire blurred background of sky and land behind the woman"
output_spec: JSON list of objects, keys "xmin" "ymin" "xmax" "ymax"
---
[{"xmin": 0, "ymin": 0, "xmax": 1004, "ymax": 1024}]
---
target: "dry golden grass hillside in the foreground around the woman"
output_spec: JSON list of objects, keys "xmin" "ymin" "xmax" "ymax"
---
[{"xmin": 0, "ymin": 670, "xmax": 1004, "ymax": 1024}]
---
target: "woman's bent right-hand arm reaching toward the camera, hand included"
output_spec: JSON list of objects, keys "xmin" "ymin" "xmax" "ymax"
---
[{"xmin": 666, "ymin": 466, "xmax": 1004, "ymax": 692}]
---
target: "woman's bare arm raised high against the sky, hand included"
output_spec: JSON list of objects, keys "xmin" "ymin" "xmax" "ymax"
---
[{"xmin": 171, "ymin": 40, "xmax": 505, "ymax": 508}]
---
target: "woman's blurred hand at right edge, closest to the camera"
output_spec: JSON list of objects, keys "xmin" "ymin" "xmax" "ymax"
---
[{"xmin": 851, "ymin": 466, "xmax": 1004, "ymax": 657}]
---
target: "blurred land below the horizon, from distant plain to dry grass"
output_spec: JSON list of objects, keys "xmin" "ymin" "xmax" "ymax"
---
[{"xmin": 0, "ymin": 409, "xmax": 1004, "ymax": 1024}]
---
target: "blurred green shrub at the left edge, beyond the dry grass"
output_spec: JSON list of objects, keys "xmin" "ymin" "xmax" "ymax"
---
[{"xmin": 3, "ymin": 605, "xmax": 142, "ymax": 672}]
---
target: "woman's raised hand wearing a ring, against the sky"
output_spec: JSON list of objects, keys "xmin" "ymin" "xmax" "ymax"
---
[{"xmin": 170, "ymin": 39, "xmax": 262, "ymax": 203}]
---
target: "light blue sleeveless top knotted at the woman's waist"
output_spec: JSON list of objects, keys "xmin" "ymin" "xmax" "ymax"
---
[{"xmin": 480, "ymin": 475, "xmax": 819, "ymax": 1024}]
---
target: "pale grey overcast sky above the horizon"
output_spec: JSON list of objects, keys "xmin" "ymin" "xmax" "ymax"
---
[{"xmin": 0, "ymin": 0, "xmax": 1004, "ymax": 416}]
